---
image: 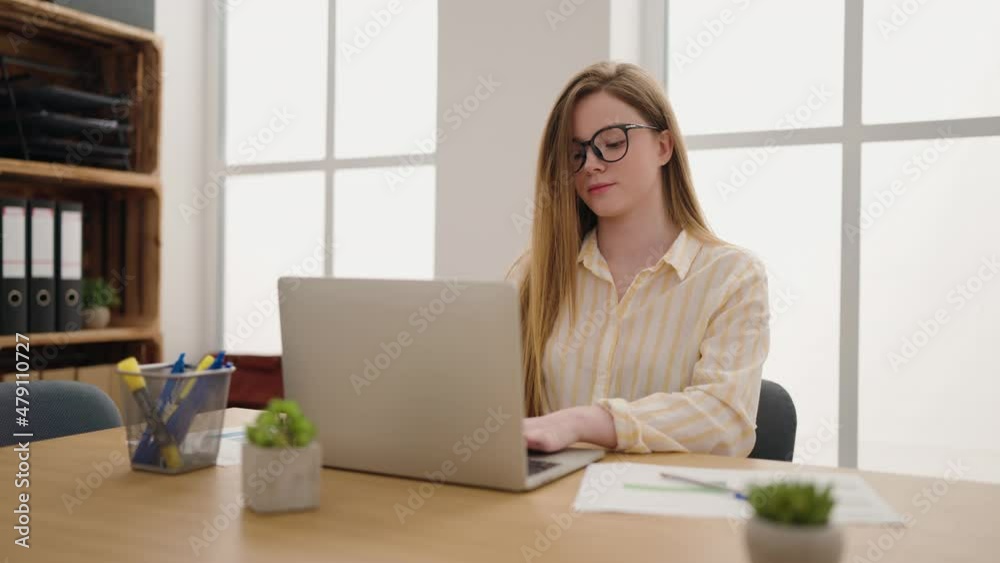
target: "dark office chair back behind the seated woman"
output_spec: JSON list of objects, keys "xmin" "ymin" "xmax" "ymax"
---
[{"xmin": 750, "ymin": 379, "xmax": 798, "ymax": 461}]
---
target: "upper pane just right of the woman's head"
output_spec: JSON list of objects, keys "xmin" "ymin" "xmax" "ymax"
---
[{"xmin": 667, "ymin": 0, "xmax": 844, "ymax": 135}]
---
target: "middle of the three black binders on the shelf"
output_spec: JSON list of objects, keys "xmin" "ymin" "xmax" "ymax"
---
[{"xmin": 28, "ymin": 200, "xmax": 56, "ymax": 332}]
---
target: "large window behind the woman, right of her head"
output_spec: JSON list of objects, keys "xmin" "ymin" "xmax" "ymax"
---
[{"xmin": 642, "ymin": 0, "xmax": 1000, "ymax": 480}]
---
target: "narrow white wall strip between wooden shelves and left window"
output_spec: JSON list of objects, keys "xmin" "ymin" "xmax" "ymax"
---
[{"xmin": 156, "ymin": 0, "xmax": 216, "ymax": 360}]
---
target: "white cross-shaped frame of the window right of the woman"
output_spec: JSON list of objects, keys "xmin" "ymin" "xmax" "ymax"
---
[{"xmin": 640, "ymin": 0, "xmax": 1000, "ymax": 468}]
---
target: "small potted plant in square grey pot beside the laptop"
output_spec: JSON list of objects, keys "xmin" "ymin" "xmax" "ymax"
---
[{"xmin": 243, "ymin": 399, "xmax": 323, "ymax": 512}]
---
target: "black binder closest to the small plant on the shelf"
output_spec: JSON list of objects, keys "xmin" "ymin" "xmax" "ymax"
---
[{"xmin": 55, "ymin": 201, "xmax": 83, "ymax": 331}]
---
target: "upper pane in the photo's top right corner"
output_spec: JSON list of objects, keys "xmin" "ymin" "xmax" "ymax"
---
[{"xmin": 862, "ymin": 0, "xmax": 1000, "ymax": 123}]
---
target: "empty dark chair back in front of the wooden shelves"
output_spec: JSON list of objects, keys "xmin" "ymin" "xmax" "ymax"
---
[{"xmin": 0, "ymin": 381, "xmax": 122, "ymax": 446}]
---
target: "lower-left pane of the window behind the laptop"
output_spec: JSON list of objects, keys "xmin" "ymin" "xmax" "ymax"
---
[{"xmin": 223, "ymin": 172, "xmax": 330, "ymax": 354}]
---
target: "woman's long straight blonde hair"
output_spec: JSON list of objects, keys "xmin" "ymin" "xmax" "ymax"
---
[{"xmin": 508, "ymin": 62, "xmax": 719, "ymax": 416}]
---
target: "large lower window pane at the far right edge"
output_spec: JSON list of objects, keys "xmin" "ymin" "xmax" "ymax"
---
[{"xmin": 855, "ymin": 137, "xmax": 1000, "ymax": 482}]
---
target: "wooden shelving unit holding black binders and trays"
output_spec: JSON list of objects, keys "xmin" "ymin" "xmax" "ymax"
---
[{"xmin": 0, "ymin": 0, "xmax": 163, "ymax": 396}]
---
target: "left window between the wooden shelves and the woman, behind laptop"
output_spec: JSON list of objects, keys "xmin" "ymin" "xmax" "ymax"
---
[{"xmin": 217, "ymin": 0, "xmax": 437, "ymax": 354}]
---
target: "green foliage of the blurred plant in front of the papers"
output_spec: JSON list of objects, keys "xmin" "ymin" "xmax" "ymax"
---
[{"xmin": 747, "ymin": 483, "xmax": 834, "ymax": 526}]
